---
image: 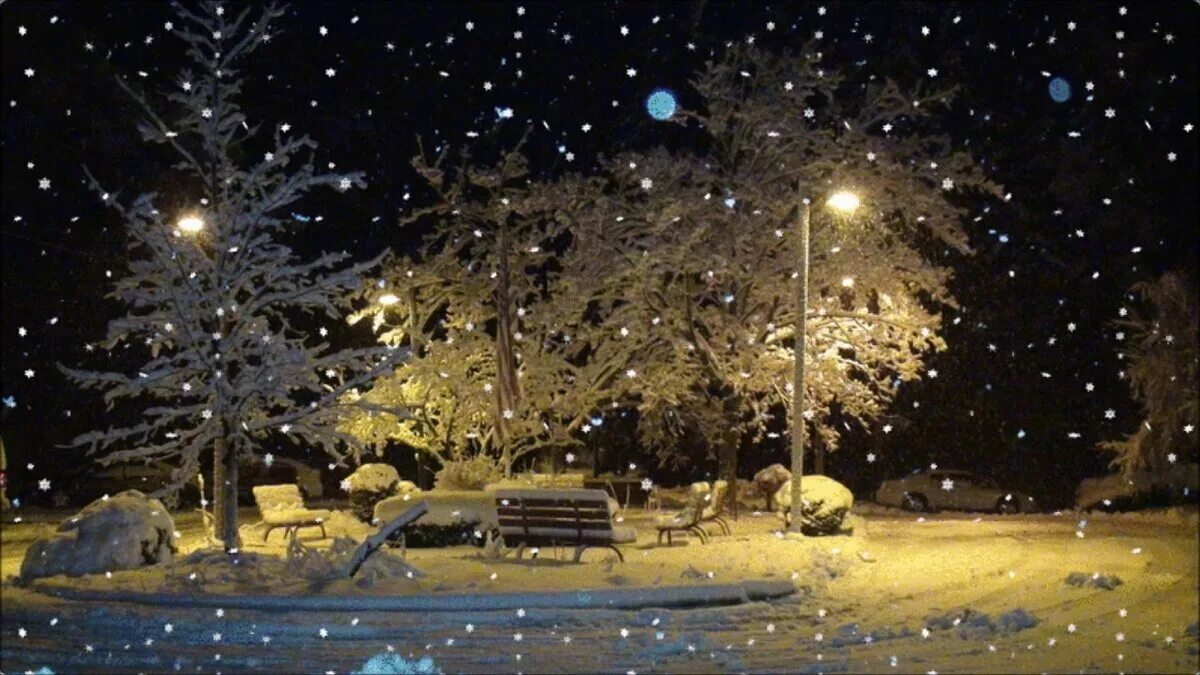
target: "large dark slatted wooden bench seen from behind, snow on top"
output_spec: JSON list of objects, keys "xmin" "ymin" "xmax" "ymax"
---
[{"xmin": 493, "ymin": 490, "xmax": 637, "ymax": 562}]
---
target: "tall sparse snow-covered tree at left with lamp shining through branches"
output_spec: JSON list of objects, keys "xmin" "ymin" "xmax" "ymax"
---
[{"xmin": 64, "ymin": 2, "xmax": 404, "ymax": 548}]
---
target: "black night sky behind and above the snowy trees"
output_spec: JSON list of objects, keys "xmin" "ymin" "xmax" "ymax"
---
[{"xmin": 0, "ymin": 0, "xmax": 1200, "ymax": 504}]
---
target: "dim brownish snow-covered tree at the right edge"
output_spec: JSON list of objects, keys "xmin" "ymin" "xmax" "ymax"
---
[{"xmin": 1100, "ymin": 271, "xmax": 1200, "ymax": 473}]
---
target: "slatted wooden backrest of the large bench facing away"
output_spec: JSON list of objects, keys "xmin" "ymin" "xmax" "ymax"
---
[{"xmin": 494, "ymin": 490, "xmax": 612, "ymax": 539}]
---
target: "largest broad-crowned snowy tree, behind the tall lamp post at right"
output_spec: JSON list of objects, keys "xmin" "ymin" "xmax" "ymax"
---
[{"xmin": 569, "ymin": 46, "xmax": 998, "ymax": 478}]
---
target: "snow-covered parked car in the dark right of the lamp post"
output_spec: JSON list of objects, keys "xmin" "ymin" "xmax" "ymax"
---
[{"xmin": 875, "ymin": 470, "xmax": 1037, "ymax": 513}]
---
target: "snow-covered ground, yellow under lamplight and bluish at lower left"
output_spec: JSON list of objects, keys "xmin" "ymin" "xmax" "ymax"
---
[{"xmin": 0, "ymin": 502, "xmax": 1200, "ymax": 673}]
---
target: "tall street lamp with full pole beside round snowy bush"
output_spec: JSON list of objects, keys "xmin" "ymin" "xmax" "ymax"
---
[{"xmin": 787, "ymin": 190, "xmax": 859, "ymax": 534}]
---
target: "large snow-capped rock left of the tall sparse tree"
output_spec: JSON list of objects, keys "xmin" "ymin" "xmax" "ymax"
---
[{"xmin": 20, "ymin": 490, "xmax": 175, "ymax": 581}]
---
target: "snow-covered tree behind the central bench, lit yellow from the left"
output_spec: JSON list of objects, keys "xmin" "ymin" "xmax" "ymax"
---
[{"xmin": 343, "ymin": 133, "xmax": 613, "ymax": 474}]
